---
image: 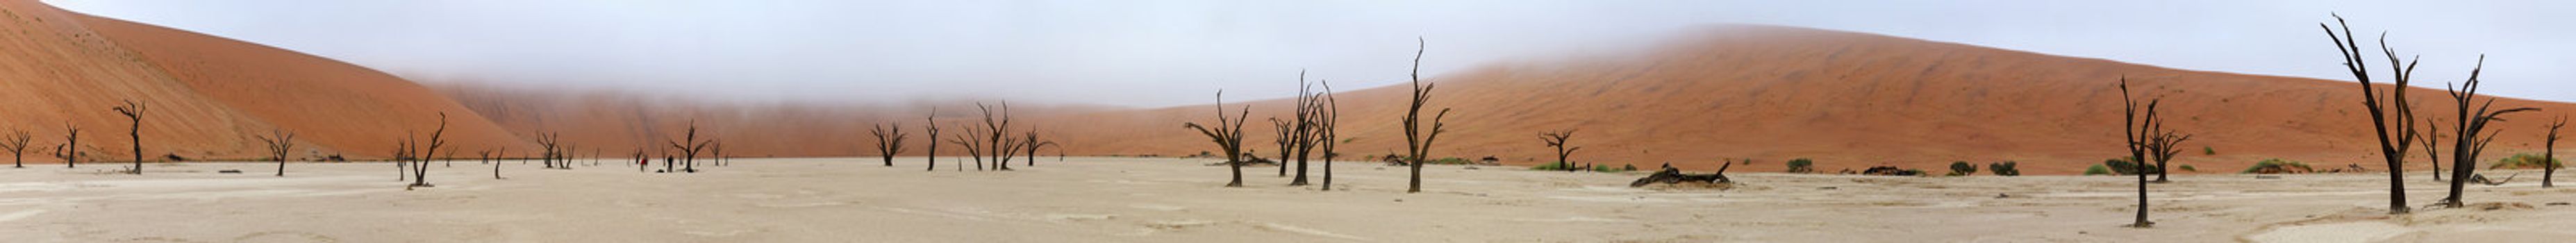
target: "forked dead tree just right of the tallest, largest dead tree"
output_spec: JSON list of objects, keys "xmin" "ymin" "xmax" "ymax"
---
[{"xmin": 2442, "ymin": 54, "xmax": 2540, "ymax": 207}]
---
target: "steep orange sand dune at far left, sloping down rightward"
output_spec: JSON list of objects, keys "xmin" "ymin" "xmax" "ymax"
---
[{"xmin": 0, "ymin": 0, "xmax": 528, "ymax": 163}]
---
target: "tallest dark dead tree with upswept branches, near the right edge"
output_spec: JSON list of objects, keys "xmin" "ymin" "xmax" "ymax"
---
[{"xmin": 2328, "ymin": 15, "xmax": 2421, "ymax": 215}]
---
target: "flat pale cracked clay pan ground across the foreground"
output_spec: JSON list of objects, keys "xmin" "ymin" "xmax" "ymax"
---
[{"xmin": 0, "ymin": 158, "xmax": 2576, "ymax": 243}]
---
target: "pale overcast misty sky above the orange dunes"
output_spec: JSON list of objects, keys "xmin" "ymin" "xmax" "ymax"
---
[{"xmin": 47, "ymin": 0, "xmax": 2576, "ymax": 106}]
